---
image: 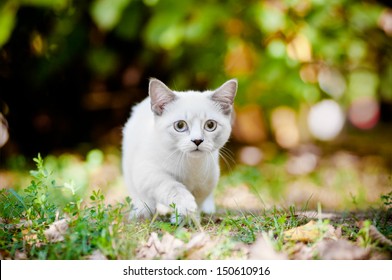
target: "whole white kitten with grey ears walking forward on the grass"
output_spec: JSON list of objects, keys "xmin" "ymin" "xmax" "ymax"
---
[{"xmin": 122, "ymin": 79, "xmax": 237, "ymax": 217}]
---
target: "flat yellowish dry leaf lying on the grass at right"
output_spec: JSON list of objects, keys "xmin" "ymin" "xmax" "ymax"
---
[{"xmin": 283, "ymin": 220, "xmax": 338, "ymax": 242}]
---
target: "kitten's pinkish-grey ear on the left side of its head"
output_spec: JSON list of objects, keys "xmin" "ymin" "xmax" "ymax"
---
[{"xmin": 148, "ymin": 78, "xmax": 176, "ymax": 116}]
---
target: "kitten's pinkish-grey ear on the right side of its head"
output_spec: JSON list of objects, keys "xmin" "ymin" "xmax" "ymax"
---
[{"xmin": 211, "ymin": 79, "xmax": 238, "ymax": 115}]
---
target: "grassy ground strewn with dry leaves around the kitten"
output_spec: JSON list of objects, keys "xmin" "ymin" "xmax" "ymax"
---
[{"xmin": 0, "ymin": 146, "xmax": 392, "ymax": 259}]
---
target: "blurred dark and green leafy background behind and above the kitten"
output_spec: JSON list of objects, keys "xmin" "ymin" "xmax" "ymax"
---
[{"xmin": 0, "ymin": 0, "xmax": 392, "ymax": 156}]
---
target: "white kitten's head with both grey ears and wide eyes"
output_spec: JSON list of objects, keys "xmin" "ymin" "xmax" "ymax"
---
[{"xmin": 149, "ymin": 79, "xmax": 237, "ymax": 157}]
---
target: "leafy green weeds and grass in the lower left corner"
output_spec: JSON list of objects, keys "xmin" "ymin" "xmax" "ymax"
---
[{"xmin": 0, "ymin": 156, "xmax": 136, "ymax": 259}]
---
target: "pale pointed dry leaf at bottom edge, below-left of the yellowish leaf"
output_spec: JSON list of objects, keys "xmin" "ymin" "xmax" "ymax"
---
[{"xmin": 249, "ymin": 233, "xmax": 288, "ymax": 260}]
